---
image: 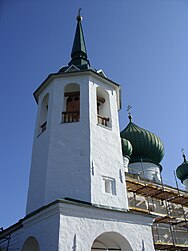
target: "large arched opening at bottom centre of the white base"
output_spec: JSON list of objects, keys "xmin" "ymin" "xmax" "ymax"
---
[{"xmin": 91, "ymin": 232, "xmax": 133, "ymax": 251}]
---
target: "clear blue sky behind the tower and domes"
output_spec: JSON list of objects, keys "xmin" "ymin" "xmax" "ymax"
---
[{"xmin": 0, "ymin": 0, "xmax": 188, "ymax": 228}]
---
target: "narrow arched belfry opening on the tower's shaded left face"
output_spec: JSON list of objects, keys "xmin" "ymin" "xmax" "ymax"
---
[{"xmin": 38, "ymin": 94, "xmax": 49, "ymax": 134}]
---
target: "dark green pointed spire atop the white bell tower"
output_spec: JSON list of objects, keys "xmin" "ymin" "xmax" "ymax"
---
[{"xmin": 69, "ymin": 9, "xmax": 90, "ymax": 67}]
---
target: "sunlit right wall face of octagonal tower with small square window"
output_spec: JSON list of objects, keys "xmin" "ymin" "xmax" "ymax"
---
[{"xmin": 89, "ymin": 78, "xmax": 128, "ymax": 209}]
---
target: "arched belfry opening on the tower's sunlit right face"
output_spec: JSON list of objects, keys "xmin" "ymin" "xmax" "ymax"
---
[{"xmin": 97, "ymin": 87, "xmax": 112, "ymax": 127}]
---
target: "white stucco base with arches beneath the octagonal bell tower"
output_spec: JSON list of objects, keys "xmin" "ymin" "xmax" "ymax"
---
[{"xmin": 6, "ymin": 201, "xmax": 154, "ymax": 251}]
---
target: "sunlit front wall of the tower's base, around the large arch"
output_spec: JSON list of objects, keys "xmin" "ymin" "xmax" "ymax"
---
[{"xmin": 59, "ymin": 201, "xmax": 154, "ymax": 251}]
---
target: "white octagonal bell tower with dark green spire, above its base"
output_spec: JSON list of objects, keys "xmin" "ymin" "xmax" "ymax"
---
[{"xmin": 26, "ymin": 13, "xmax": 128, "ymax": 214}]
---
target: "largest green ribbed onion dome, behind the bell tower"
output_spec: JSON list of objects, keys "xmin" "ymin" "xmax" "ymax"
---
[{"xmin": 120, "ymin": 116, "xmax": 164, "ymax": 165}]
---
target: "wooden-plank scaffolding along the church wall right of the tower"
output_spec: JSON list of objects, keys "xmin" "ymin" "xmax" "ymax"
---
[{"xmin": 125, "ymin": 173, "xmax": 188, "ymax": 251}]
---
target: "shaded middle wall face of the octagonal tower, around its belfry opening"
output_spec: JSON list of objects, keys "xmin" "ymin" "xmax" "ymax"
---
[{"xmin": 43, "ymin": 77, "xmax": 90, "ymax": 203}]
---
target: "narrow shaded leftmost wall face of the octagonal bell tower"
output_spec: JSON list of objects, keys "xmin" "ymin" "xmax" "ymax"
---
[{"xmin": 26, "ymin": 82, "xmax": 53, "ymax": 214}]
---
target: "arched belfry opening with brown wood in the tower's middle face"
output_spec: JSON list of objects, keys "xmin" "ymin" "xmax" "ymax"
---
[{"xmin": 62, "ymin": 84, "xmax": 80, "ymax": 123}]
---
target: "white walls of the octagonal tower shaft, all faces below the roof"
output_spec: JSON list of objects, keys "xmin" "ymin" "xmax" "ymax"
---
[{"xmin": 26, "ymin": 73, "xmax": 128, "ymax": 214}]
